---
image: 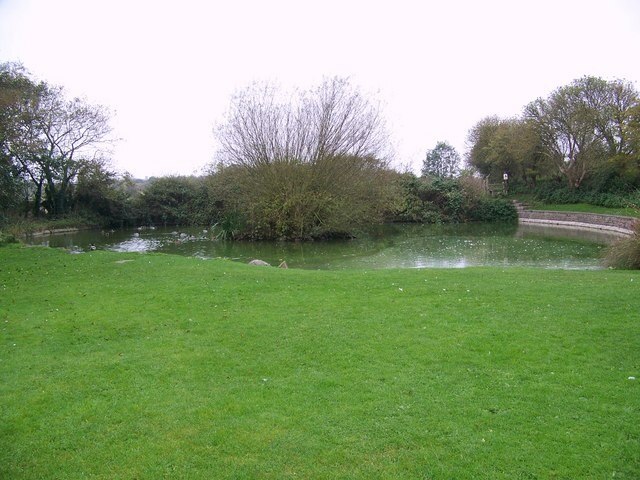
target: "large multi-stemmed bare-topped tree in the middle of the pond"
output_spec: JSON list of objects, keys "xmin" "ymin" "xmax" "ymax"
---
[{"xmin": 216, "ymin": 78, "xmax": 396, "ymax": 238}]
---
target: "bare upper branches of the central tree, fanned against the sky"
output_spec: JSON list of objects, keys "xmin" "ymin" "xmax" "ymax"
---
[{"xmin": 216, "ymin": 78, "xmax": 388, "ymax": 167}]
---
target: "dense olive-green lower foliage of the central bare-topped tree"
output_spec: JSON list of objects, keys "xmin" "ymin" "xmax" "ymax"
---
[{"xmin": 211, "ymin": 157, "xmax": 394, "ymax": 240}]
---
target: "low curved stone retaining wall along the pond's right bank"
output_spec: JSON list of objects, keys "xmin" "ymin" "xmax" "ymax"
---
[{"xmin": 518, "ymin": 209, "xmax": 639, "ymax": 235}]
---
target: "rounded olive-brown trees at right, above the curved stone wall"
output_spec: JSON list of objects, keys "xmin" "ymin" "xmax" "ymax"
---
[{"xmin": 467, "ymin": 76, "xmax": 640, "ymax": 206}]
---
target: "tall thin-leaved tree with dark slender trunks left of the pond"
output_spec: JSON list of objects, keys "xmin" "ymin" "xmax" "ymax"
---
[{"xmin": 2, "ymin": 62, "xmax": 111, "ymax": 215}]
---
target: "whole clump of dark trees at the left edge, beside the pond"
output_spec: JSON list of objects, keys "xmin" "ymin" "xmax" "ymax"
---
[{"xmin": 0, "ymin": 64, "xmax": 111, "ymax": 217}]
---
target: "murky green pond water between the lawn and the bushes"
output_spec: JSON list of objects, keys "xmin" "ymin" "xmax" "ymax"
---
[{"xmin": 27, "ymin": 224, "xmax": 615, "ymax": 270}]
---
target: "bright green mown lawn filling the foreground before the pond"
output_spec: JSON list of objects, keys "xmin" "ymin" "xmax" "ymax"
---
[{"xmin": 0, "ymin": 245, "xmax": 640, "ymax": 479}]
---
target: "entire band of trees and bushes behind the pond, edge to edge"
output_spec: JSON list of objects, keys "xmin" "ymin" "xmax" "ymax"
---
[{"xmin": 11, "ymin": 63, "xmax": 640, "ymax": 239}]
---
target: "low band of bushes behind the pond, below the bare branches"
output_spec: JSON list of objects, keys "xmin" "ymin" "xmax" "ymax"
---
[{"xmin": 51, "ymin": 168, "xmax": 517, "ymax": 240}]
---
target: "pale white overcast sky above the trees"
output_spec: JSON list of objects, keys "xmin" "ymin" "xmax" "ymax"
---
[{"xmin": 0, "ymin": 0, "xmax": 640, "ymax": 178}]
